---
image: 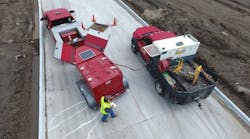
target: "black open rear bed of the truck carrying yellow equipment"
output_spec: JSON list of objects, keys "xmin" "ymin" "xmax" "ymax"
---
[{"xmin": 151, "ymin": 61, "xmax": 215, "ymax": 106}]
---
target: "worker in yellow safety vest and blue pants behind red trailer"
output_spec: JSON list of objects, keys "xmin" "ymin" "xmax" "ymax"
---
[{"xmin": 100, "ymin": 96, "xmax": 117, "ymax": 122}]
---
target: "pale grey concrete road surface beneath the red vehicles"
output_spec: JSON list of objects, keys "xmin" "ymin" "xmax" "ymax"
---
[{"xmin": 42, "ymin": 0, "xmax": 250, "ymax": 139}]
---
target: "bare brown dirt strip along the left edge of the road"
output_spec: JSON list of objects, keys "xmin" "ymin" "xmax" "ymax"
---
[{"xmin": 0, "ymin": 0, "xmax": 38, "ymax": 139}]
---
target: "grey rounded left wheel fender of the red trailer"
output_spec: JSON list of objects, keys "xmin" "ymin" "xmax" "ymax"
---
[{"xmin": 76, "ymin": 80, "xmax": 97, "ymax": 109}]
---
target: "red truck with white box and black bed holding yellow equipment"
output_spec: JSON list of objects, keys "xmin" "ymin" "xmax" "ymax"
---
[{"xmin": 131, "ymin": 26, "xmax": 215, "ymax": 106}]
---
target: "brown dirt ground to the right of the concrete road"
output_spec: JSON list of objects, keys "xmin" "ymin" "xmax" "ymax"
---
[{"xmin": 123, "ymin": 0, "xmax": 250, "ymax": 116}]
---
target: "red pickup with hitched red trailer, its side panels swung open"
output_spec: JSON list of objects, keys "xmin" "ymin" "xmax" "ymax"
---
[{"xmin": 41, "ymin": 8, "xmax": 128, "ymax": 109}]
